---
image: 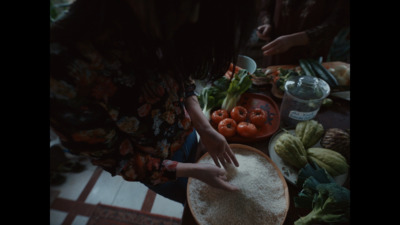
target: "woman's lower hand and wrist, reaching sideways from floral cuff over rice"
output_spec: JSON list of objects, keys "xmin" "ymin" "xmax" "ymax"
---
[{"xmin": 176, "ymin": 163, "xmax": 239, "ymax": 191}]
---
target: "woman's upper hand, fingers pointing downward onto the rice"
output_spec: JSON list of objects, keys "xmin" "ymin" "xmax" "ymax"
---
[{"xmin": 200, "ymin": 128, "xmax": 239, "ymax": 167}]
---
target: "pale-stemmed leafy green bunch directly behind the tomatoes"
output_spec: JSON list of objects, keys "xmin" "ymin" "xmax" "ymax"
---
[{"xmin": 221, "ymin": 69, "xmax": 252, "ymax": 112}]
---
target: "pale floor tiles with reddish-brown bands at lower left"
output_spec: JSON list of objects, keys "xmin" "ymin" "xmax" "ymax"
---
[{"xmin": 50, "ymin": 150, "xmax": 183, "ymax": 225}]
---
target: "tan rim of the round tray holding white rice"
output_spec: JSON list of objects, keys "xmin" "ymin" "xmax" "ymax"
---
[{"xmin": 186, "ymin": 144, "xmax": 289, "ymax": 225}]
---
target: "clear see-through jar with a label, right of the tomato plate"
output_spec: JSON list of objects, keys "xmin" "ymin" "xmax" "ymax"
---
[{"xmin": 280, "ymin": 76, "xmax": 330, "ymax": 128}]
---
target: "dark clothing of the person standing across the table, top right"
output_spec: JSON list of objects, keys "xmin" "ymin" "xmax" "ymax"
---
[{"xmin": 259, "ymin": 0, "xmax": 349, "ymax": 67}]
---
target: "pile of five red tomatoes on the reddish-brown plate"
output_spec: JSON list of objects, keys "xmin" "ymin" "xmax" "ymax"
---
[{"xmin": 211, "ymin": 106, "xmax": 267, "ymax": 138}]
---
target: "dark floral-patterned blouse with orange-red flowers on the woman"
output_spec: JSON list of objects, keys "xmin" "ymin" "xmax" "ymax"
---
[{"xmin": 50, "ymin": 36, "xmax": 195, "ymax": 185}]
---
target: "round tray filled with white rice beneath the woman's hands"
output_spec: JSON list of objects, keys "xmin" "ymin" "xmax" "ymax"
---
[{"xmin": 188, "ymin": 144, "xmax": 289, "ymax": 225}]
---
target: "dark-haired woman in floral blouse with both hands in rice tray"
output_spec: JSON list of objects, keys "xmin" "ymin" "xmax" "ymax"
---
[{"xmin": 50, "ymin": 0, "xmax": 256, "ymax": 203}]
